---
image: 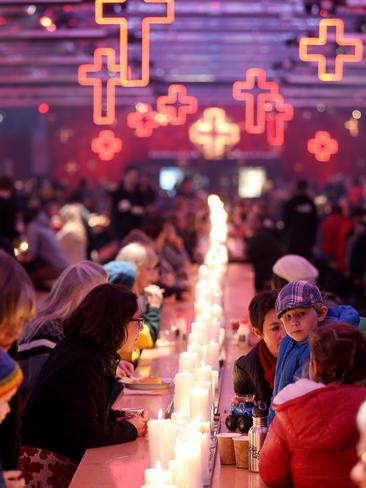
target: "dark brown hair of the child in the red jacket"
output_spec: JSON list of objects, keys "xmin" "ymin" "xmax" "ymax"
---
[{"xmin": 310, "ymin": 322, "xmax": 366, "ymax": 386}]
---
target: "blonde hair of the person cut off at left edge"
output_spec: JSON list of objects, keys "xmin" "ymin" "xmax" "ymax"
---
[{"xmin": 0, "ymin": 250, "xmax": 36, "ymax": 327}]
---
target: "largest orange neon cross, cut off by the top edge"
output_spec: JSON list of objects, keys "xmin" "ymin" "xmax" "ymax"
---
[{"xmin": 95, "ymin": 0, "xmax": 175, "ymax": 87}]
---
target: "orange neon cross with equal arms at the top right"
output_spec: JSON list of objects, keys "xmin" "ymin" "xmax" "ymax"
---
[{"xmin": 299, "ymin": 19, "xmax": 363, "ymax": 81}]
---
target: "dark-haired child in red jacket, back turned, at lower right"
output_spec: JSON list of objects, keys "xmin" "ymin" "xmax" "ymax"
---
[{"xmin": 259, "ymin": 323, "xmax": 366, "ymax": 488}]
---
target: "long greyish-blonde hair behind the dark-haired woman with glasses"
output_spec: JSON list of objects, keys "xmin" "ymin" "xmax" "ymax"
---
[{"xmin": 24, "ymin": 261, "xmax": 107, "ymax": 342}]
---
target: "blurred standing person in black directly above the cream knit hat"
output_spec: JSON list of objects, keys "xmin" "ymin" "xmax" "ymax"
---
[{"xmin": 283, "ymin": 180, "xmax": 318, "ymax": 259}]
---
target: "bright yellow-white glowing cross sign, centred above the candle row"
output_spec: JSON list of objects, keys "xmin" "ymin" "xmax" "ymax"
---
[{"xmin": 189, "ymin": 108, "xmax": 240, "ymax": 159}]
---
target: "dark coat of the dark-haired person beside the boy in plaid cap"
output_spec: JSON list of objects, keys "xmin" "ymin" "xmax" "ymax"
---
[{"xmin": 233, "ymin": 344, "xmax": 272, "ymax": 407}]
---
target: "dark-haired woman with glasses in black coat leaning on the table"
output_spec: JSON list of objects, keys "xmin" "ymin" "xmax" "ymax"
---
[{"xmin": 22, "ymin": 283, "xmax": 147, "ymax": 462}]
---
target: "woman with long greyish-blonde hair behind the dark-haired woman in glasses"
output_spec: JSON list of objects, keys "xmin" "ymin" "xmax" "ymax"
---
[{"xmin": 18, "ymin": 261, "xmax": 107, "ymax": 397}]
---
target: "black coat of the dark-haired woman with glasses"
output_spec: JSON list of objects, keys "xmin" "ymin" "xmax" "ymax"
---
[{"xmin": 22, "ymin": 336, "xmax": 138, "ymax": 462}]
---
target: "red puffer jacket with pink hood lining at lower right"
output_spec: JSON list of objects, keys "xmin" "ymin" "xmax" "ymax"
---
[{"xmin": 259, "ymin": 379, "xmax": 366, "ymax": 488}]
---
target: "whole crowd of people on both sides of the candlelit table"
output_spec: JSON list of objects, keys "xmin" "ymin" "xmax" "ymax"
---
[{"xmin": 0, "ymin": 167, "xmax": 366, "ymax": 488}]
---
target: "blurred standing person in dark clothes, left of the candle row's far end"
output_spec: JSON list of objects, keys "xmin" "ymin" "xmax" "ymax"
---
[{"xmin": 111, "ymin": 166, "xmax": 146, "ymax": 243}]
